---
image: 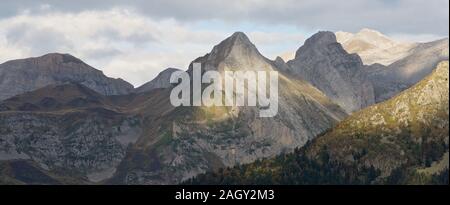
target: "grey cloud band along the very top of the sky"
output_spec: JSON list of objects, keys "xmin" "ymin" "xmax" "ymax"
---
[{"xmin": 0, "ymin": 0, "xmax": 449, "ymax": 35}]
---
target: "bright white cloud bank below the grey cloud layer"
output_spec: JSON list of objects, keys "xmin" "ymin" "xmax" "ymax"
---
[{"xmin": 0, "ymin": 6, "xmax": 314, "ymax": 86}]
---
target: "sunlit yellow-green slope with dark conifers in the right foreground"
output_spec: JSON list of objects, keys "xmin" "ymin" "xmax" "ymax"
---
[{"xmin": 185, "ymin": 61, "xmax": 449, "ymax": 184}]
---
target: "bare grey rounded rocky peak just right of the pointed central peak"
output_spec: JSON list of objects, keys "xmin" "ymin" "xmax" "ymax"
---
[{"xmin": 287, "ymin": 32, "xmax": 375, "ymax": 113}]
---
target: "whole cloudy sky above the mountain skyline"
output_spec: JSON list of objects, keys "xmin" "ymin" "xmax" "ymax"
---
[{"xmin": 0, "ymin": 0, "xmax": 449, "ymax": 86}]
